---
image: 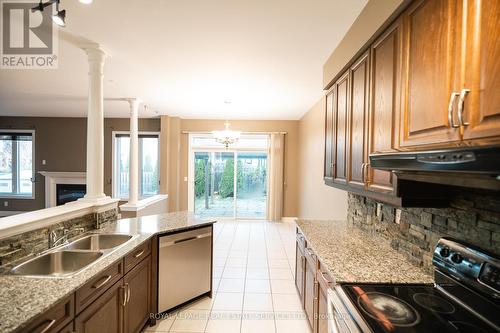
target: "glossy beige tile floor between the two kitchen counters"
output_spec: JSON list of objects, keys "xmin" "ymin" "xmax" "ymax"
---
[{"xmin": 144, "ymin": 221, "xmax": 310, "ymax": 333}]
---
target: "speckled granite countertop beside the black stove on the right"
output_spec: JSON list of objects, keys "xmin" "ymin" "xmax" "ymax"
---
[{"xmin": 297, "ymin": 219, "xmax": 434, "ymax": 283}]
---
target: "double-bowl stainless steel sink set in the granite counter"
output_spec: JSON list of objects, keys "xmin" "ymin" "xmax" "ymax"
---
[{"xmin": 10, "ymin": 233, "xmax": 136, "ymax": 277}]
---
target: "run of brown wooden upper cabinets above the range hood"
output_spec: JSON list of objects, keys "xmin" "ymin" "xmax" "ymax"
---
[{"xmin": 325, "ymin": 0, "xmax": 500, "ymax": 204}]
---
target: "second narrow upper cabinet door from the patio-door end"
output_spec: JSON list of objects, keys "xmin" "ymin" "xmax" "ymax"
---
[{"xmin": 333, "ymin": 71, "xmax": 349, "ymax": 184}]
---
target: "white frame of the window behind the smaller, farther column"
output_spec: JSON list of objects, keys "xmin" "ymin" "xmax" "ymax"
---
[{"xmin": 111, "ymin": 131, "xmax": 161, "ymax": 201}]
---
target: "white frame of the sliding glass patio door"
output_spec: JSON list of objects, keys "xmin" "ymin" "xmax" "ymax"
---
[{"xmin": 188, "ymin": 147, "xmax": 269, "ymax": 220}]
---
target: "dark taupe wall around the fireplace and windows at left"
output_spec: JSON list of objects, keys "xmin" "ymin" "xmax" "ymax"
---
[{"xmin": 0, "ymin": 117, "xmax": 160, "ymax": 211}]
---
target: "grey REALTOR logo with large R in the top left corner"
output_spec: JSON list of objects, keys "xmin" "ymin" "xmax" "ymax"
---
[{"xmin": 0, "ymin": 0, "xmax": 57, "ymax": 69}]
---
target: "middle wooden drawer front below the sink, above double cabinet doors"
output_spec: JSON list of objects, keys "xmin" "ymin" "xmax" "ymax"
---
[{"xmin": 76, "ymin": 260, "xmax": 123, "ymax": 313}]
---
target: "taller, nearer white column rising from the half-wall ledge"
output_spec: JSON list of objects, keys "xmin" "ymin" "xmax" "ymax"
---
[{"xmin": 83, "ymin": 45, "xmax": 106, "ymax": 202}]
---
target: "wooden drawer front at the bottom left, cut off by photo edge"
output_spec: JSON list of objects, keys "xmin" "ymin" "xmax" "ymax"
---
[{"xmin": 17, "ymin": 294, "xmax": 75, "ymax": 333}]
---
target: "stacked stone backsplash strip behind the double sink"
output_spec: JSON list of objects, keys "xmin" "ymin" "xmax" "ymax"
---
[{"xmin": 0, "ymin": 208, "xmax": 118, "ymax": 266}]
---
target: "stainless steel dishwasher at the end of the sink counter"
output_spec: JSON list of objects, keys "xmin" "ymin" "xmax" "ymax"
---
[{"xmin": 158, "ymin": 227, "xmax": 212, "ymax": 312}]
